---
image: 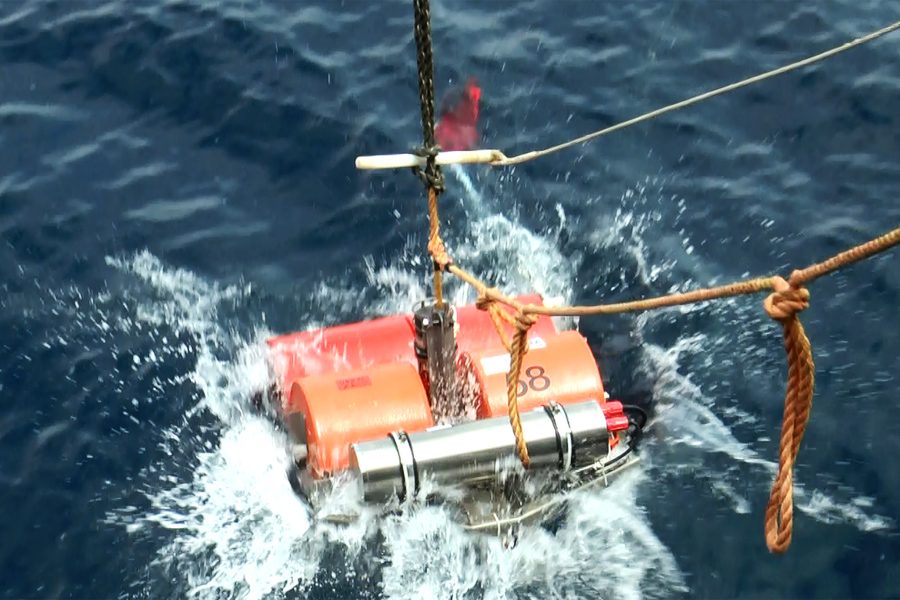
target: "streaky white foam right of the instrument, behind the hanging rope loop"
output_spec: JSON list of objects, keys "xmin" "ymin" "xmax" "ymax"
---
[{"xmin": 592, "ymin": 186, "xmax": 893, "ymax": 531}]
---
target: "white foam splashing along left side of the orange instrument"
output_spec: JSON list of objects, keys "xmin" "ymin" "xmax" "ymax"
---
[{"xmin": 102, "ymin": 252, "xmax": 321, "ymax": 598}]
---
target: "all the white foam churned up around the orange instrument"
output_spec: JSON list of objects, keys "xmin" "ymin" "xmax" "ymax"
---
[{"xmin": 100, "ymin": 171, "xmax": 881, "ymax": 600}]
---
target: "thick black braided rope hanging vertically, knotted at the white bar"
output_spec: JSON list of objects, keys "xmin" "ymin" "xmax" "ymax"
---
[{"xmin": 413, "ymin": 0, "xmax": 444, "ymax": 194}]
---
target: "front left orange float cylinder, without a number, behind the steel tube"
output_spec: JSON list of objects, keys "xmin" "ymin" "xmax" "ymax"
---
[{"xmin": 284, "ymin": 362, "xmax": 434, "ymax": 477}]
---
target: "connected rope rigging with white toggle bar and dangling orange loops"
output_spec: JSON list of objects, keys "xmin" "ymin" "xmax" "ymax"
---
[{"xmin": 408, "ymin": 0, "xmax": 900, "ymax": 553}]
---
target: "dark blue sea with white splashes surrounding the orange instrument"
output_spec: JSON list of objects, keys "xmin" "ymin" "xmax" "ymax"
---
[{"xmin": 0, "ymin": 0, "xmax": 900, "ymax": 599}]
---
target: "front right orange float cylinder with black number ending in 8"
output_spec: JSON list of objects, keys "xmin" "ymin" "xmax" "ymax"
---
[{"xmin": 460, "ymin": 331, "xmax": 605, "ymax": 418}]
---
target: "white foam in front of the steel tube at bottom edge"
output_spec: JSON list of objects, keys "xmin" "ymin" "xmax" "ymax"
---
[{"xmin": 383, "ymin": 471, "xmax": 685, "ymax": 600}]
